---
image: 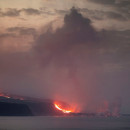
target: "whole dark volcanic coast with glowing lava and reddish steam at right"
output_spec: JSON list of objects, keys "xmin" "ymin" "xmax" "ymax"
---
[{"xmin": 0, "ymin": 92, "xmax": 120, "ymax": 117}]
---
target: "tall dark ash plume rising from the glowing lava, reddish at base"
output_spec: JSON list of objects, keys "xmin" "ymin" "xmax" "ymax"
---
[{"xmin": 34, "ymin": 7, "xmax": 103, "ymax": 111}]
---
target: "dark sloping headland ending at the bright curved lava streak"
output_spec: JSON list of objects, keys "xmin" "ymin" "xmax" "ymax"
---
[{"xmin": 0, "ymin": 93, "xmax": 69, "ymax": 116}]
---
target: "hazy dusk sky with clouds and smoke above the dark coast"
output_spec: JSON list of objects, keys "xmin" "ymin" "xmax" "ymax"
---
[{"xmin": 0, "ymin": 0, "xmax": 130, "ymax": 113}]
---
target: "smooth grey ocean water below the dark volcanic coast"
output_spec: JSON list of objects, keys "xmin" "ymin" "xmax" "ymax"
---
[{"xmin": 0, "ymin": 116, "xmax": 130, "ymax": 130}]
